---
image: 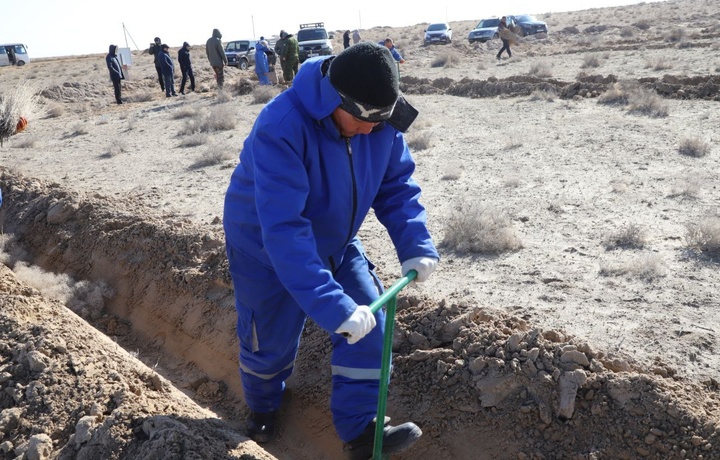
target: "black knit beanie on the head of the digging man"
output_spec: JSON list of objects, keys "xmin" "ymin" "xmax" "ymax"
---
[{"xmin": 328, "ymin": 42, "xmax": 400, "ymax": 122}]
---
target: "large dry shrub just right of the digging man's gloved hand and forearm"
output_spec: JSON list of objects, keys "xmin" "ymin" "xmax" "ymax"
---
[{"xmin": 441, "ymin": 201, "xmax": 522, "ymax": 254}]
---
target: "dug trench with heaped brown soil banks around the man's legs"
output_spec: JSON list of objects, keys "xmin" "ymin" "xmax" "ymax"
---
[{"xmin": 0, "ymin": 168, "xmax": 720, "ymax": 460}]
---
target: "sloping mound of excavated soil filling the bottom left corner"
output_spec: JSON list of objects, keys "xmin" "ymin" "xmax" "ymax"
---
[{"xmin": 0, "ymin": 265, "xmax": 274, "ymax": 460}]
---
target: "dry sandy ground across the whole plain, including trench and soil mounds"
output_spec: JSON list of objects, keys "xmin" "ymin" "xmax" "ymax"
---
[{"xmin": 0, "ymin": 0, "xmax": 720, "ymax": 460}]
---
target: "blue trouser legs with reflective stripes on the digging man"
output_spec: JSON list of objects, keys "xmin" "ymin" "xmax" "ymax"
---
[{"xmin": 227, "ymin": 241, "xmax": 385, "ymax": 442}]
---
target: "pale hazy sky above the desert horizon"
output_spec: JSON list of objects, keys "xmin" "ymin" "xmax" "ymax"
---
[{"xmin": 0, "ymin": 0, "xmax": 664, "ymax": 59}]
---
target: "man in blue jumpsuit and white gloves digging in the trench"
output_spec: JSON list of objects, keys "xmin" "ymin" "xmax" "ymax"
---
[{"xmin": 223, "ymin": 42, "xmax": 439, "ymax": 459}]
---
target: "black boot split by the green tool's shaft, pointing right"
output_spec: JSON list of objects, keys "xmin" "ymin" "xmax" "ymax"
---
[{"xmin": 343, "ymin": 421, "xmax": 422, "ymax": 460}]
